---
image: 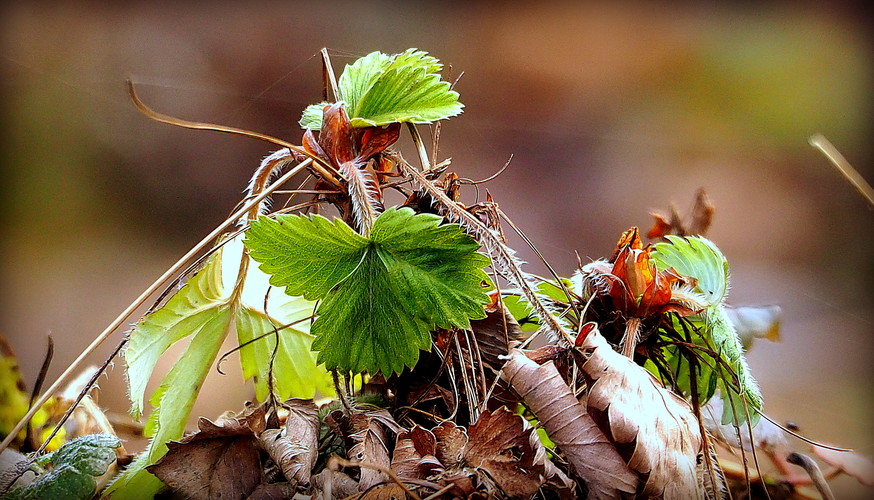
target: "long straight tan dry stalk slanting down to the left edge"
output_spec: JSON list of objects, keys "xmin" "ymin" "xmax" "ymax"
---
[{"xmin": 0, "ymin": 160, "xmax": 312, "ymax": 451}]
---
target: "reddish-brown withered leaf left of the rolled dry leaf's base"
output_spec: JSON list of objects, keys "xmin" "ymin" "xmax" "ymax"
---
[{"xmin": 464, "ymin": 406, "xmax": 544, "ymax": 498}]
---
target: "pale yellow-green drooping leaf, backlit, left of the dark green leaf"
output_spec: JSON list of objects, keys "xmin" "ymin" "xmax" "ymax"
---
[{"xmin": 113, "ymin": 237, "xmax": 333, "ymax": 498}]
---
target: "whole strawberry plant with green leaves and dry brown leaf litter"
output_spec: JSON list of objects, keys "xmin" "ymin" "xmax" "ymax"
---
[{"xmin": 4, "ymin": 49, "xmax": 864, "ymax": 500}]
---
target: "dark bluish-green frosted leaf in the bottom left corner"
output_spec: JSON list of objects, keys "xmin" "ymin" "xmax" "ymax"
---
[{"xmin": 3, "ymin": 434, "xmax": 121, "ymax": 500}]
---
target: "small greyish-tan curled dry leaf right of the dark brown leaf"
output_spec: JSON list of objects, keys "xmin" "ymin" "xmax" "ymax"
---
[{"xmin": 258, "ymin": 399, "xmax": 319, "ymax": 486}]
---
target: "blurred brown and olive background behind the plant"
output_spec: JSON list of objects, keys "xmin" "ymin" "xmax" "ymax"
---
[{"xmin": 0, "ymin": 2, "xmax": 874, "ymax": 495}]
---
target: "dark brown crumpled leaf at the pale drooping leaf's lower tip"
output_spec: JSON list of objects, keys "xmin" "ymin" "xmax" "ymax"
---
[{"xmin": 147, "ymin": 406, "xmax": 266, "ymax": 498}]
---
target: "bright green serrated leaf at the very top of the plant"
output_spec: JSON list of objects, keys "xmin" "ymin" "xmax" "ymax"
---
[{"xmin": 300, "ymin": 49, "xmax": 464, "ymax": 130}]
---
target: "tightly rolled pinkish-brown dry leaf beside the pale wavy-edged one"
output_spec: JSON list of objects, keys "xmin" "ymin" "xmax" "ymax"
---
[{"xmin": 503, "ymin": 349, "xmax": 638, "ymax": 500}]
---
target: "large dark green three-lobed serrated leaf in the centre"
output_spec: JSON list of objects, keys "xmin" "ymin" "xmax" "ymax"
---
[{"xmin": 246, "ymin": 208, "xmax": 489, "ymax": 374}]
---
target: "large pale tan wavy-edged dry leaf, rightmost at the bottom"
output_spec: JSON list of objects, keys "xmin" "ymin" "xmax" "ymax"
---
[{"xmin": 580, "ymin": 329, "xmax": 703, "ymax": 499}]
